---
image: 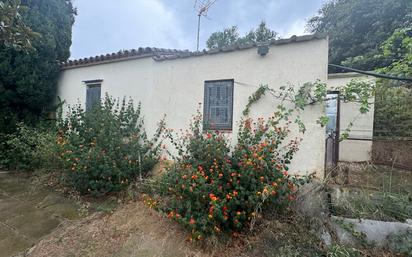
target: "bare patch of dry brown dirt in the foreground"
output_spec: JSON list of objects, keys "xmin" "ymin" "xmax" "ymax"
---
[{"xmin": 27, "ymin": 202, "xmax": 209, "ymax": 257}]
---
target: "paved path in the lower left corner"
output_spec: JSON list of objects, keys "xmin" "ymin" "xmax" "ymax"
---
[{"xmin": 0, "ymin": 173, "xmax": 79, "ymax": 257}]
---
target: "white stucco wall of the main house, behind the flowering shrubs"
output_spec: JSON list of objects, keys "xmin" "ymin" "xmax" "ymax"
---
[{"xmin": 58, "ymin": 38, "xmax": 328, "ymax": 177}]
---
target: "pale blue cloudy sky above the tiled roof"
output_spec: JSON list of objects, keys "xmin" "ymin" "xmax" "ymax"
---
[{"xmin": 70, "ymin": 0, "xmax": 325, "ymax": 59}]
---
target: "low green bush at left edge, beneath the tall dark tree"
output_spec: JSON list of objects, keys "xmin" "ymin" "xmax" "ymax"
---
[{"xmin": 0, "ymin": 123, "xmax": 56, "ymax": 171}]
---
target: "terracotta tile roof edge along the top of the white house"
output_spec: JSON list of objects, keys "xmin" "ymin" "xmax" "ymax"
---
[{"xmin": 61, "ymin": 33, "xmax": 326, "ymax": 69}]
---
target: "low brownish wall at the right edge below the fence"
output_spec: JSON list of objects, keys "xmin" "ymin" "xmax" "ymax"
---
[{"xmin": 372, "ymin": 139, "xmax": 412, "ymax": 170}]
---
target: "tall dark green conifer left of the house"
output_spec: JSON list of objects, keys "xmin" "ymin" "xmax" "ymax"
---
[{"xmin": 0, "ymin": 0, "xmax": 75, "ymax": 133}]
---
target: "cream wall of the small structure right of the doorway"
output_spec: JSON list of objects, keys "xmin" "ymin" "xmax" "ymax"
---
[{"xmin": 328, "ymin": 73, "xmax": 374, "ymax": 162}]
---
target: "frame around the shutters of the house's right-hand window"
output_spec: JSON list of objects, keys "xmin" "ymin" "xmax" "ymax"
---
[{"xmin": 203, "ymin": 79, "xmax": 235, "ymax": 132}]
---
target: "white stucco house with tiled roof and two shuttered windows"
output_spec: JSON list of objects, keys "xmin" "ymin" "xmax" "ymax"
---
[{"xmin": 58, "ymin": 34, "xmax": 374, "ymax": 177}]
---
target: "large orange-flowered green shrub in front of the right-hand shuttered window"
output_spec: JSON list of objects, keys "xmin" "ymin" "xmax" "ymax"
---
[{"xmin": 159, "ymin": 110, "xmax": 308, "ymax": 239}]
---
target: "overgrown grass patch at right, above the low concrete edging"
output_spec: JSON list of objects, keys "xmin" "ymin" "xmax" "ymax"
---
[{"xmin": 330, "ymin": 164, "xmax": 412, "ymax": 222}]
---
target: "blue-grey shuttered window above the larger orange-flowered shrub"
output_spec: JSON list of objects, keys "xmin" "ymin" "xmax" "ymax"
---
[{"xmin": 203, "ymin": 79, "xmax": 234, "ymax": 130}]
